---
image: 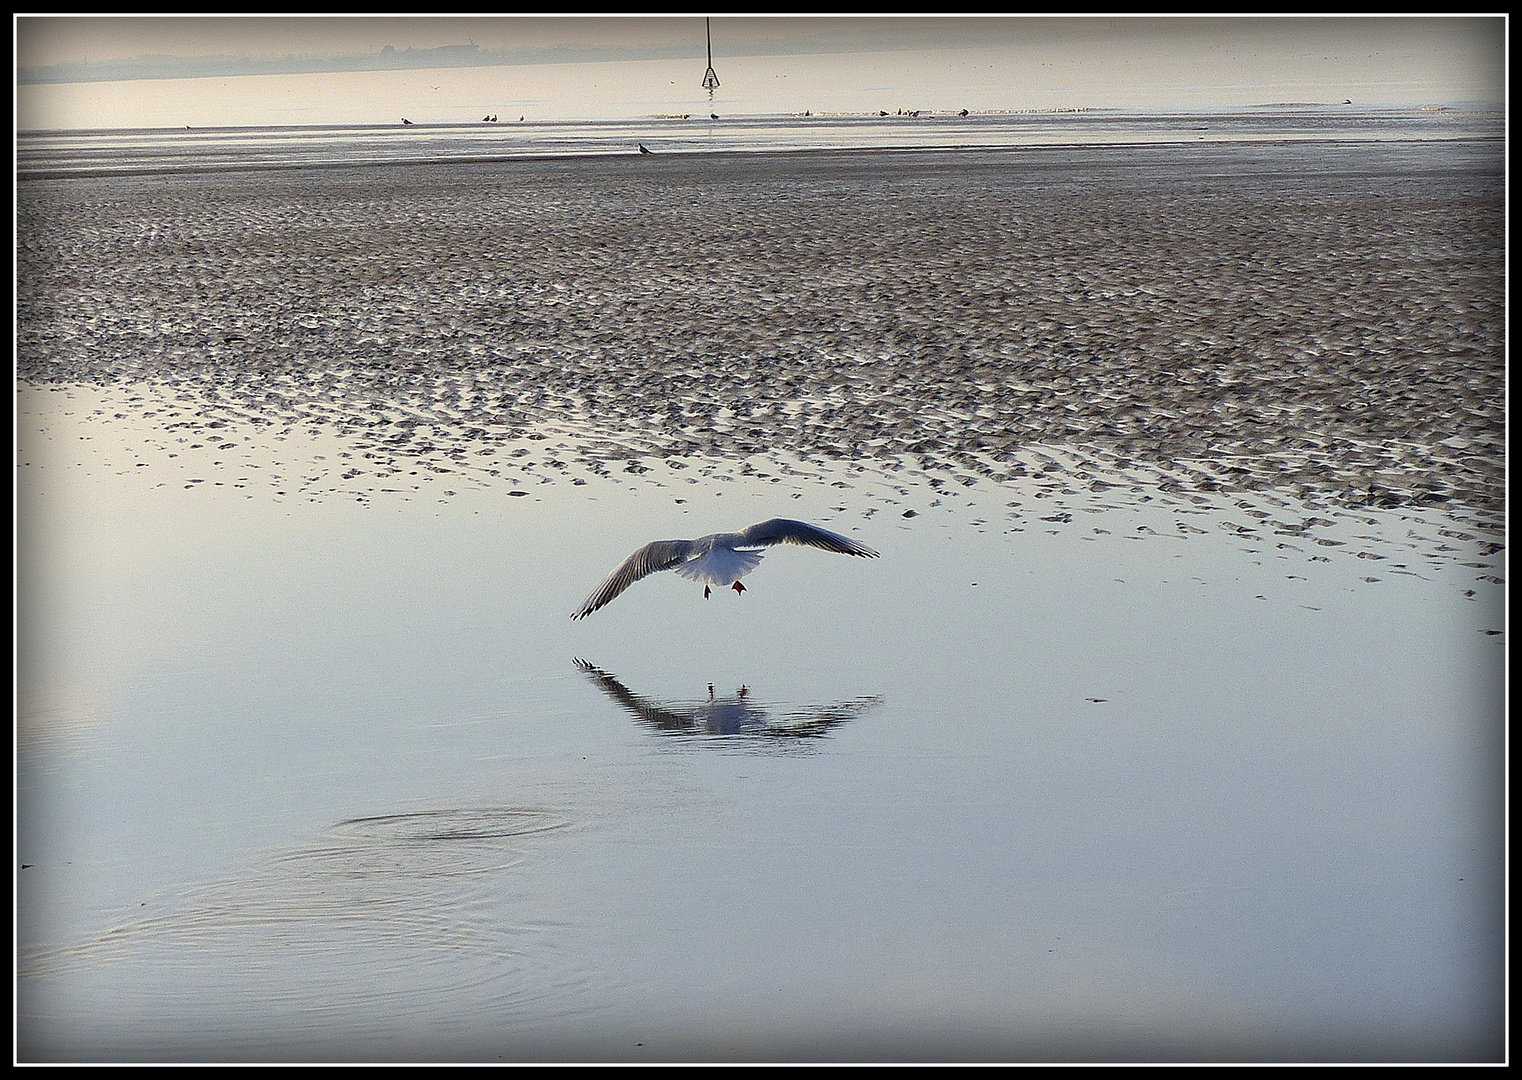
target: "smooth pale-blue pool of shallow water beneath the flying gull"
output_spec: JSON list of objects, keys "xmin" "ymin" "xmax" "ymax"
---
[{"xmin": 18, "ymin": 388, "xmax": 1504, "ymax": 1060}]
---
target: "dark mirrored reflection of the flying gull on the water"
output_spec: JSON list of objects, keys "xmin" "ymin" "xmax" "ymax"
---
[{"xmin": 575, "ymin": 659, "xmax": 883, "ymax": 739}]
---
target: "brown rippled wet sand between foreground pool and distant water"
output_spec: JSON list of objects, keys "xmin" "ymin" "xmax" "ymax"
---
[{"xmin": 18, "ymin": 143, "xmax": 1504, "ymax": 550}]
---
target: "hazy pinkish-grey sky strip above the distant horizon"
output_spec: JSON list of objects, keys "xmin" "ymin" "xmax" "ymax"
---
[{"xmin": 17, "ymin": 15, "xmax": 1504, "ymax": 80}]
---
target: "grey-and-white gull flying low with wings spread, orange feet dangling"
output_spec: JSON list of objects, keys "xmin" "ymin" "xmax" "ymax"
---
[{"xmin": 571, "ymin": 517, "xmax": 877, "ymax": 619}]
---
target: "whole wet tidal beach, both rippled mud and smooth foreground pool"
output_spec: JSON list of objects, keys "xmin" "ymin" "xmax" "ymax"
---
[{"xmin": 17, "ymin": 138, "xmax": 1505, "ymax": 1060}]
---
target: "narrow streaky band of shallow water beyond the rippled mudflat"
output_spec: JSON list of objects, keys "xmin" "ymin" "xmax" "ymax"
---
[{"xmin": 15, "ymin": 105, "xmax": 1504, "ymax": 178}]
